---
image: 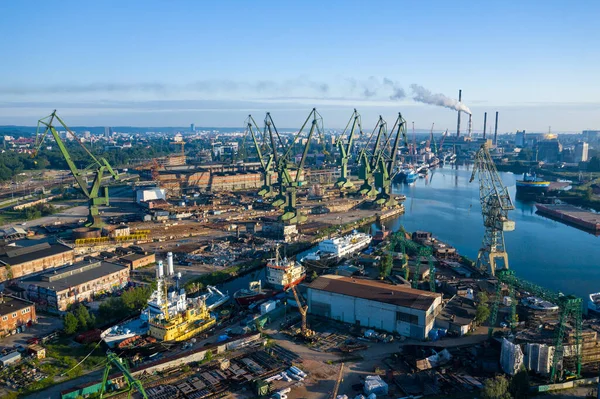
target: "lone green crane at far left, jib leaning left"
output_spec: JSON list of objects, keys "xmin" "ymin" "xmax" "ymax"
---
[{"xmin": 34, "ymin": 110, "xmax": 119, "ymax": 227}]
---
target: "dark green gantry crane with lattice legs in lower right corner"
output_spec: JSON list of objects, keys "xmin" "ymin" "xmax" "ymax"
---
[{"xmin": 488, "ymin": 269, "xmax": 582, "ymax": 382}]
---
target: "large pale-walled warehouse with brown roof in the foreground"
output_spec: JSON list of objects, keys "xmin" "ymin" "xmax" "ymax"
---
[{"xmin": 308, "ymin": 275, "xmax": 442, "ymax": 339}]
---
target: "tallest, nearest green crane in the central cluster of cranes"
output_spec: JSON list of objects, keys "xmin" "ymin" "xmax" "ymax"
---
[{"xmin": 274, "ymin": 108, "xmax": 323, "ymax": 224}]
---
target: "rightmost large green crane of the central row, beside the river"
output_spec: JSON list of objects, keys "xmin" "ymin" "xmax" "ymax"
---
[{"xmin": 374, "ymin": 112, "xmax": 408, "ymax": 208}]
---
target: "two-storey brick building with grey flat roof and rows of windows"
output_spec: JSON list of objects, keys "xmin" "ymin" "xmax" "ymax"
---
[{"xmin": 21, "ymin": 260, "xmax": 129, "ymax": 313}]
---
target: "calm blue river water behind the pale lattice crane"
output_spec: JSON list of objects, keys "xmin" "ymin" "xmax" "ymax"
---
[{"xmin": 386, "ymin": 166, "xmax": 600, "ymax": 298}]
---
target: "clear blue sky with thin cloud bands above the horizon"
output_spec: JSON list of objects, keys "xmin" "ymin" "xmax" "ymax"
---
[{"xmin": 0, "ymin": 0, "xmax": 600, "ymax": 132}]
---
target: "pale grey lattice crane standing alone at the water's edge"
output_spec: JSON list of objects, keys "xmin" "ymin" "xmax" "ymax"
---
[{"xmin": 469, "ymin": 144, "xmax": 515, "ymax": 276}]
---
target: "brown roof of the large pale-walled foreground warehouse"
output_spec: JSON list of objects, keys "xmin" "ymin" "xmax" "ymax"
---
[{"xmin": 309, "ymin": 275, "xmax": 441, "ymax": 310}]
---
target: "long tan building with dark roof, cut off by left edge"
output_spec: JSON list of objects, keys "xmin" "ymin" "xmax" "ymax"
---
[{"xmin": 0, "ymin": 242, "xmax": 74, "ymax": 282}]
